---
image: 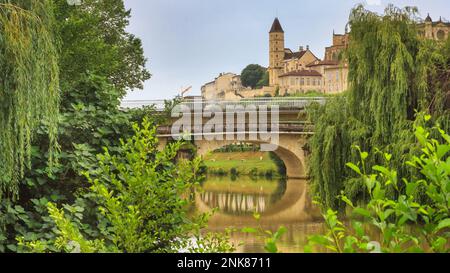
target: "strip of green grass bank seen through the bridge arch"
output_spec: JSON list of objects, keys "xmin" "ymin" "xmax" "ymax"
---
[{"xmin": 205, "ymin": 152, "xmax": 277, "ymax": 175}]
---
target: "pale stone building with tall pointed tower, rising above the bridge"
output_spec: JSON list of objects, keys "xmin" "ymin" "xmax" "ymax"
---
[{"xmin": 269, "ymin": 18, "xmax": 348, "ymax": 95}]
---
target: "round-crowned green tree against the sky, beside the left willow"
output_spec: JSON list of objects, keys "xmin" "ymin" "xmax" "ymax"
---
[{"xmin": 53, "ymin": 0, "xmax": 150, "ymax": 94}]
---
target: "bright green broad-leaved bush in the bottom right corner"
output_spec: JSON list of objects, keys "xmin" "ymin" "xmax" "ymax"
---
[{"xmin": 306, "ymin": 120, "xmax": 450, "ymax": 252}]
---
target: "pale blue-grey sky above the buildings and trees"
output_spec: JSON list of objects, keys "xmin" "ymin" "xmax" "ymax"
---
[{"xmin": 124, "ymin": 0, "xmax": 450, "ymax": 100}]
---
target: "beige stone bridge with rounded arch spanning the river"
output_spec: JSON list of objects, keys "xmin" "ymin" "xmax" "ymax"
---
[{"xmin": 119, "ymin": 98, "xmax": 325, "ymax": 179}]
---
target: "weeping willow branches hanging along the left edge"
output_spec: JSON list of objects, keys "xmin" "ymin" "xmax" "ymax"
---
[{"xmin": 0, "ymin": 0, "xmax": 59, "ymax": 198}]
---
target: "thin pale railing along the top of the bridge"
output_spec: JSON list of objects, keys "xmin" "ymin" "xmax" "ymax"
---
[{"xmin": 121, "ymin": 97, "xmax": 326, "ymax": 111}]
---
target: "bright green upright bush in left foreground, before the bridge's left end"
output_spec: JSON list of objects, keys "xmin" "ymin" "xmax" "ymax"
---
[{"xmin": 18, "ymin": 119, "xmax": 233, "ymax": 253}]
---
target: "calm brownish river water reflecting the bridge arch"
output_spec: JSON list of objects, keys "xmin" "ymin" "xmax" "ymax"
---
[{"xmin": 195, "ymin": 176, "xmax": 323, "ymax": 253}]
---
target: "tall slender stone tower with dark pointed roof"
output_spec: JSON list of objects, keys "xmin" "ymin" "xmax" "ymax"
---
[{"xmin": 269, "ymin": 18, "xmax": 284, "ymax": 86}]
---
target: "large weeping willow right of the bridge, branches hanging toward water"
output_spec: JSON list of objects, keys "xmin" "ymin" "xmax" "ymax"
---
[{"xmin": 310, "ymin": 5, "xmax": 450, "ymax": 209}]
